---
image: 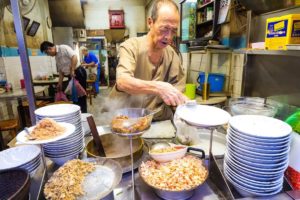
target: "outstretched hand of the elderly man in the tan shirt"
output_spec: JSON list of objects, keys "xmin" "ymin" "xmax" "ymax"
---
[{"xmin": 157, "ymin": 81, "xmax": 187, "ymax": 106}]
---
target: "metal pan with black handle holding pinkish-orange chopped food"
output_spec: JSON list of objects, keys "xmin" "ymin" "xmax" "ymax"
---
[{"xmin": 139, "ymin": 147, "xmax": 209, "ymax": 200}]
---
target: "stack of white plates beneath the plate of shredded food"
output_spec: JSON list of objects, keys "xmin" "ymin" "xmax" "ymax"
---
[{"xmin": 35, "ymin": 104, "xmax": 84, "ymax": 165}]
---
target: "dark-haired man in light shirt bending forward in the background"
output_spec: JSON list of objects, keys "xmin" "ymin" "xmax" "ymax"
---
[{"xmin": 40, "ymin": 41, "xmax": 87, "ymax": 113}]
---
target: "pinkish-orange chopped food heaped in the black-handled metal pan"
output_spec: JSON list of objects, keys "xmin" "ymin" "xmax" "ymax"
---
[{"xmin": 140, "ymin": 155, "xmax": 208, "ymax": 191}]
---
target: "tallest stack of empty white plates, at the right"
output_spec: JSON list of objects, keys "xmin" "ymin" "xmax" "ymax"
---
[{"xmin": 224, "ymin": 115, "xmax": 292, "ymax": 196}]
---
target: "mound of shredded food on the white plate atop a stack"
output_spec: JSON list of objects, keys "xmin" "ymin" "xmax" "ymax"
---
[{"xmin": 26, "ymin": 118, "xmax": 65, "ymax": 140}]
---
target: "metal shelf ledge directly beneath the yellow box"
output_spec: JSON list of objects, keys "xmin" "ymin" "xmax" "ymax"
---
[{"xmin": 234, "ymin": 50, "xmax": 300, "ymax": 57}]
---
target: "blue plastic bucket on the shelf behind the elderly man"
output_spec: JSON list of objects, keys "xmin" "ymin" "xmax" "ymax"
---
[{"xmin": 197, "ymin": 72, "xmax": 225, "ymax": 92}]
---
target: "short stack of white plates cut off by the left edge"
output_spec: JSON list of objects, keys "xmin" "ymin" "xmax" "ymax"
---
[{"xmin": 0, "ymin": 145, "xmax": 41, "ymax": 175}]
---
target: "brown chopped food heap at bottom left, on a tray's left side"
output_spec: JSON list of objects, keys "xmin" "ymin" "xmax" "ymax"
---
[{"xmin": 44, "ymin": 159, "xmax": 95, "ymax": 200}]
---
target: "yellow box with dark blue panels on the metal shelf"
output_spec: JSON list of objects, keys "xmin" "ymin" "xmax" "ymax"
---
[{"xmin": 265, "ymin": 14, "xmax": 300, "ymax": 50}]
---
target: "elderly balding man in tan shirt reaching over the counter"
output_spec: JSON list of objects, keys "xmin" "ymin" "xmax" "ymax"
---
[{"xmin": 110, "ymin": 0, "xmax": 187, "ymax": 120}]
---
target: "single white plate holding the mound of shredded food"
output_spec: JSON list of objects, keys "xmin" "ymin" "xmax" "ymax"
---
[{"xmin": 17, "ymin": 122, "xmax": 75, "ymax": 144}]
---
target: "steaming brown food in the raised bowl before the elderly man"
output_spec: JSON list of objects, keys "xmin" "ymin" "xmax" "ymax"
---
[{"xmin": 112, "ymin": 115, "xmax": 150, "ymax": 133}]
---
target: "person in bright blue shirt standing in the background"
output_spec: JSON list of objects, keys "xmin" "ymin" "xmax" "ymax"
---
[{"xmin": 80, "ymin": 46, "xmax": 101, "ymax": 94}]
